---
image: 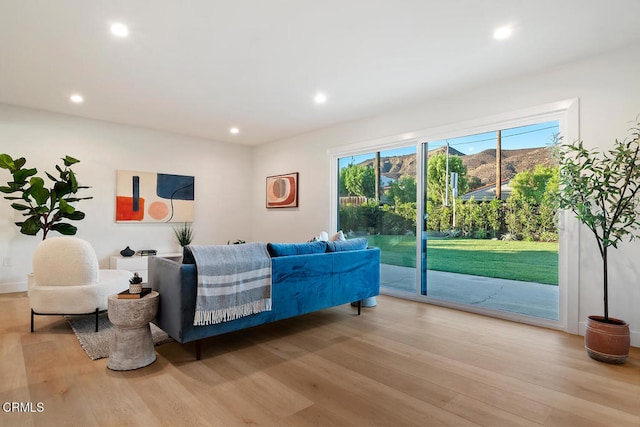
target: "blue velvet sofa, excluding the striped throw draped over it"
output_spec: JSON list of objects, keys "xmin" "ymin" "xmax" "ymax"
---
[{"xmin": 149, "ymin": 239, "xmax": 380, "ymax": 359}]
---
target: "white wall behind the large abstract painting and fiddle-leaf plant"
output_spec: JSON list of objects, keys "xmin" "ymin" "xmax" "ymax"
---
[{"xmin": 0, "ymin": 105, "xmax": 252, "ymax": 292}]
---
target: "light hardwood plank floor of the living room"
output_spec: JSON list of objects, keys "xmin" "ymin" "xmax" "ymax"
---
[{"xmin": 0, "ymin": 293, "xmax": 640, "ymax": 427}]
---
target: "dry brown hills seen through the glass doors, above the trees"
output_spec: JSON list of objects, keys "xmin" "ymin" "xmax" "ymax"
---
[{"xmin": 360, "ymin": 147, "xmax": 555, "ymax": 186}]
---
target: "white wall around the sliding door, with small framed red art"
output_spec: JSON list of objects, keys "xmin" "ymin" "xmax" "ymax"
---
[{"xmin": 252, "ymin": 41, "xmax": 640, "ymax": 346}]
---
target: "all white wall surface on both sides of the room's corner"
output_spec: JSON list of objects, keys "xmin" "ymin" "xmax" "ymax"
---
[{"xmin": 0, "ymin": 41, "xmax": 640, "ymax": 346}]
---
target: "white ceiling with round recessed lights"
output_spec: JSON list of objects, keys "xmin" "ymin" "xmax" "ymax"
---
[{"xmin": 0, "ymin": 0, "xmax": 640, "ymax": 145}]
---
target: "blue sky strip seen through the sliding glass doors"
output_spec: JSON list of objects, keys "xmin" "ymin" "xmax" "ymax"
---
[{"xmin": 339, "ymin": 121, "xmax": 560, "ymax": 169}]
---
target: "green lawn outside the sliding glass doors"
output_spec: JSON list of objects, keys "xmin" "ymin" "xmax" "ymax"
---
[{"xmin": 368, "ymin": 236, "xmax": 558, "ymax": 285}]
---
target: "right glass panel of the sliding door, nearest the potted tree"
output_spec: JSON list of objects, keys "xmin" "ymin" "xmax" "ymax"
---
[{"xmin": 418, "ymin": 121, "xmax": 559, "ymax": 320}]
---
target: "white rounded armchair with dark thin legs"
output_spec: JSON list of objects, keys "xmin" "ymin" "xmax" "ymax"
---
[{"xmin": 29, "ymin": 236, "xmax": 131, "ymax": 332}]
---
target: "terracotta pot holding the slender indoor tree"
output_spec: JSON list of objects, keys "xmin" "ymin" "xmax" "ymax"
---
[{"xmin": 584, "ymin": 316, "xmax": 631, "ymax": 364}]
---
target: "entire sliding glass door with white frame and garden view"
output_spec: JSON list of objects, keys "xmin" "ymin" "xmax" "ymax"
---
[{"xmin": 332, "ymin": 101, "xmax": 578, "ymax": 332}]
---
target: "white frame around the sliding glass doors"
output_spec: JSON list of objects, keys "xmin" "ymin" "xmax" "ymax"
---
[{"xmin": 328, "ymin": 98, "xmax": 580, "ymax": 334}]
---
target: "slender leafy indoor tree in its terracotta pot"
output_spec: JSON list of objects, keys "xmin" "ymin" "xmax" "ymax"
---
[{"xmin": 555, "ymin": 116, "xmax": 640, "ymax": 364}]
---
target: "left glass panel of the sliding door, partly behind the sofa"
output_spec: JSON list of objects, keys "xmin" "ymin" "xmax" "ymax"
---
[{"xmin": 338, "ymin": 145, "xmax": 420, "ymax": 294}]
